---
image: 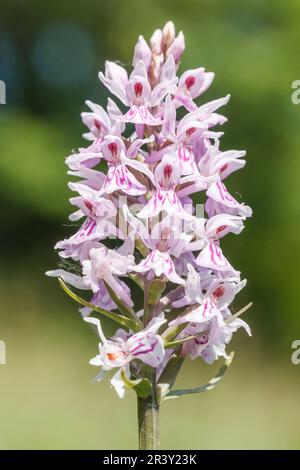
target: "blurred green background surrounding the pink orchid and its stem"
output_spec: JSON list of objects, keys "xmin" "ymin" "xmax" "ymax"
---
[{"xmin": 0, "ymin": 0, "xmax": 300, "ymax": 449}]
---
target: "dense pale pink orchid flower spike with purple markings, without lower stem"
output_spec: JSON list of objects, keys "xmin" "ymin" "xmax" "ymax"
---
[{"xmin": 47, "ymin": 22, "xmax": 251, "ymax": 397}]
